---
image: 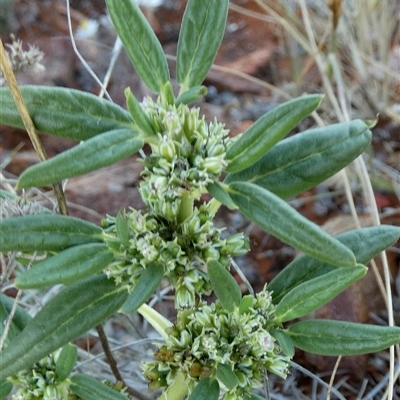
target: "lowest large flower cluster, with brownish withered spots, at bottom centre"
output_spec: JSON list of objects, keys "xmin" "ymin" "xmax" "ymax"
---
[{"xmin": 143, "ymin": 288, "xmax": 290, "ymax": 400}]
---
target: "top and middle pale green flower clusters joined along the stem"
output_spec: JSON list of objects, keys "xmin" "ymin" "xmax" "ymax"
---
[{"xmin": 103, "ymin": 97, "xmax": 249, "ymax": 308}]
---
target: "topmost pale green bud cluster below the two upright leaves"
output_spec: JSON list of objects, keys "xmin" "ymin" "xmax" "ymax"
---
[{"xmin": 140, "ymin": 98, "xmax": 230, "ymax": 220}]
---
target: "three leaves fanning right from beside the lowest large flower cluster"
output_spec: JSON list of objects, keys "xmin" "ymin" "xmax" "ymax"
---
[{"xmin": 268, "ymin": 225, "xmax": 400, "ymax": 356}]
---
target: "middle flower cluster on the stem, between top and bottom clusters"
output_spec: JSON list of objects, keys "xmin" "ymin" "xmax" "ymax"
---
[{"xmin": 101, "ymin": 203, "xmax": 248, "ymax": 308}]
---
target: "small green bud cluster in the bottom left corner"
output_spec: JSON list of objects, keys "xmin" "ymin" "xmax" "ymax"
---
[{"xmin": 8, "ymin": 349, "xmax": 72, "ymax": 400}]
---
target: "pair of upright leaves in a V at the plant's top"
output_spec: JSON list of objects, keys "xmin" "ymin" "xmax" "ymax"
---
[{"xmin": 106, "ymin": 0, "xmax": 229, "ymax": 94}]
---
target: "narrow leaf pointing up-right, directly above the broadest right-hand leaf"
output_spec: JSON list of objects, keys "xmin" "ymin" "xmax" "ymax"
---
[{"xmin": 226, "ymin": 95, "xmax": 323, "ymax": 172}]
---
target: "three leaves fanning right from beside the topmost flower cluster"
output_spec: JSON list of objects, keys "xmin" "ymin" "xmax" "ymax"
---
[{"xmin": 216, "ymin": 112, "xmax": 371, "ymax": 267}]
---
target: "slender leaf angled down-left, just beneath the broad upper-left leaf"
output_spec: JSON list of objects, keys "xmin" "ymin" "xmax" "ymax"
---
[{"xmin": 17, "ymin": 128, "xmax": 144, "ymax": 189}]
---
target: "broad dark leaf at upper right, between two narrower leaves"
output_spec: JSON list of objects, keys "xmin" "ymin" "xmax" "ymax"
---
[{"xmin": 225, "ymin": 120, "xmax": 372, "ymax": 198}]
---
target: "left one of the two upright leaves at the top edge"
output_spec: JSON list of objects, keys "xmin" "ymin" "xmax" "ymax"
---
[{"xmin": 106, "ymin": 0, "xmax": 169, "ymax": 93}]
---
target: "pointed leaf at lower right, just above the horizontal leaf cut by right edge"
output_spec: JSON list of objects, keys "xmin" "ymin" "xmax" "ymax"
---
[{"xmin": 275, "ymin": 264, "xmax": 368, "ymax": 322}]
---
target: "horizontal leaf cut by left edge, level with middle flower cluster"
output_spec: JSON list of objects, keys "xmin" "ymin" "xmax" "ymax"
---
[{"xmin": 0, "ymin": 214, "xmax": 103, "ymax": 253}]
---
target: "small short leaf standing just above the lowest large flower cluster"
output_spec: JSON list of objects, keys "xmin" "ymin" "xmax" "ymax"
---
[{"xmin": 207, "ymin": 260, "xmax": 242, "ymax": 312}]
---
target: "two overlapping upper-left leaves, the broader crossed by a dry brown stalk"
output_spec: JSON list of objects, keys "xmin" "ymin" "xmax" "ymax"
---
[{"xmin": 0, "ymin": 85, "xmax": 144, "ymax": 188}]
